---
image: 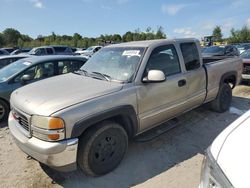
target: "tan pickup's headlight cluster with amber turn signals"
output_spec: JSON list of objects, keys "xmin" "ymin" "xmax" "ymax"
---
[{"xmin": 31, "ymin": 115, "xmax": 65, "ymax": 141}]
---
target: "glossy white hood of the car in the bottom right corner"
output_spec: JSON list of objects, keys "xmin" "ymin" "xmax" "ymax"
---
[{"xmin": 211, "ymin": 111, "xmax": 250, "ymax": 187}]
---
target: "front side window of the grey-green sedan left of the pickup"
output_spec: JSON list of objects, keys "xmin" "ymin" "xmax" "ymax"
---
[{"xmin": 14, "ymin": 62, "xmax": 54, "ymax": 82}]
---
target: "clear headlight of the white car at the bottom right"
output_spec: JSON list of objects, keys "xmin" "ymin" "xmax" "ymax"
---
[{"xmin": 199, "ymin": 148, "xmax": 233, "ymax": 188}]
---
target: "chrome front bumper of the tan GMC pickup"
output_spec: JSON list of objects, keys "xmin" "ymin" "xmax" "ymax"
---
[{"xmin": 8, "ymin": 113, "xmax": 78, "ymax": 171}]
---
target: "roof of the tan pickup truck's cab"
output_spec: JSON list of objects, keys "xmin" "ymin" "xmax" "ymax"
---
[{"xmin": 105, "ymin": 38, "xmax": 198, "ymax": 48}]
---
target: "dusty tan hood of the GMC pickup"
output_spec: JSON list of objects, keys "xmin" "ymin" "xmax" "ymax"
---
[{"xmin": 11, "ymin": 73, "xmax": 122, "ymax": 116}]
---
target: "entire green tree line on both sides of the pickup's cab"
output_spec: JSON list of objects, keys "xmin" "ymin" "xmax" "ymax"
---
[{"xmin": 0, "ymin": 25, "xmax": 250, "ymax": 48}]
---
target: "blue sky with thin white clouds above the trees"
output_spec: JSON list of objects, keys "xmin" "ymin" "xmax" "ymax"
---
[{"xmin": 0, "ymin": 0, "xmax": 250, "ymax": 38}]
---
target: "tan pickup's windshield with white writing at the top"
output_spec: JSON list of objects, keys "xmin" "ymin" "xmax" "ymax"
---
[{"xmin": 81, "ymin": 47, "xmax": 145, "ymax": 82}]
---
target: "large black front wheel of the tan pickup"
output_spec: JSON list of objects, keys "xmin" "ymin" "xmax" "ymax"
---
[{"xmin": 77, "ymin": 121, "xmax": 128, "ymax": 176}]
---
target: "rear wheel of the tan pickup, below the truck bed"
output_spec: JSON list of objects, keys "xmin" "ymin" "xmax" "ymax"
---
[{"xmin": 211, "ymin": 83, "xmax": 232, "ymax": 113}]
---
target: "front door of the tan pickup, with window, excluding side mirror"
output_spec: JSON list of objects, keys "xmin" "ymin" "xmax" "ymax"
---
[{"xmin": 137, "ymin": 44, "xmax": 187, "ymax": 131}]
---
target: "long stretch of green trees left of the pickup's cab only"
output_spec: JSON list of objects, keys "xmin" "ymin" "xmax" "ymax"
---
[{"xmin": 0, "ymin": 26, "xmax": 167, "ymax": 48}]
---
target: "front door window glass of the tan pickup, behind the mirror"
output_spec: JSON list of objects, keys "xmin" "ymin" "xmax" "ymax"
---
[{"xmin": 144, "ymin": 45, "xmax": 181, "ymax": 76}]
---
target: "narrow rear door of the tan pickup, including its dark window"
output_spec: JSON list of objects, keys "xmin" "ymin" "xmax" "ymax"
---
[{"xmin": 180, "ymin": 42, "xmax": 206, "ymax": 109}]
